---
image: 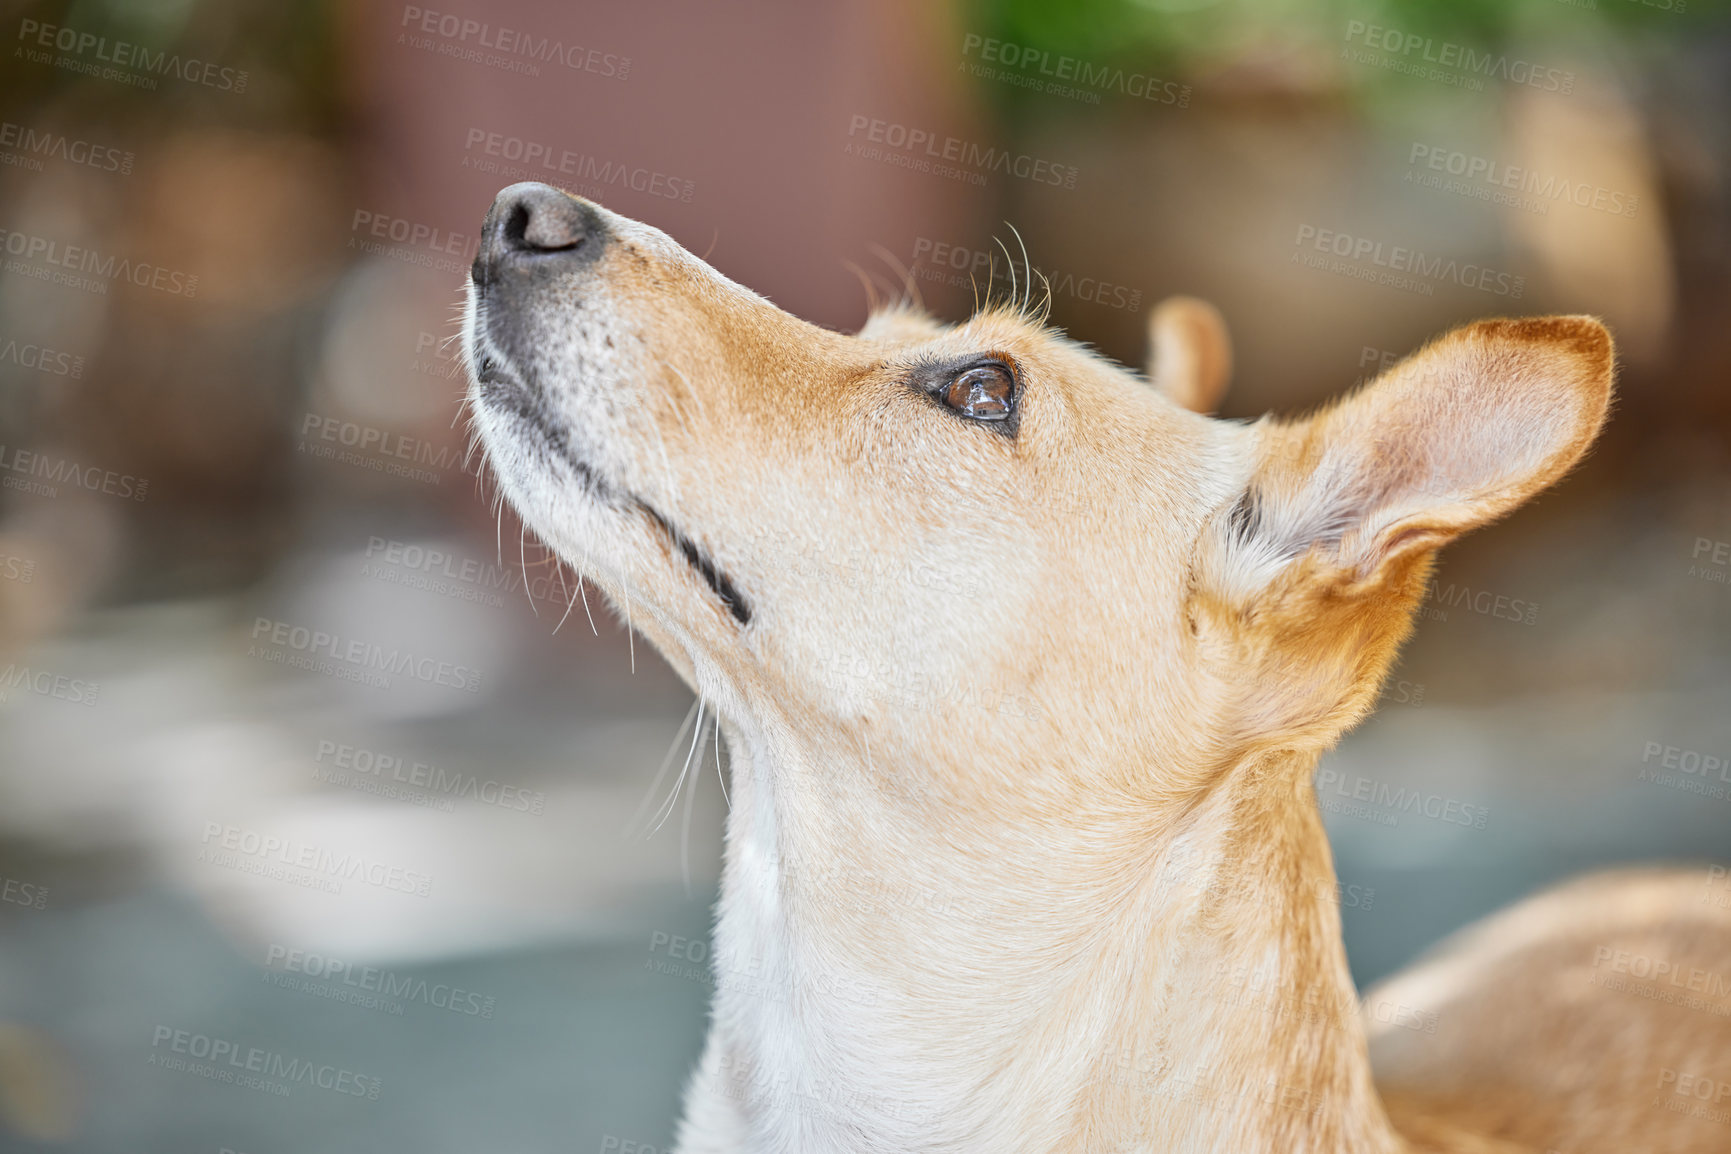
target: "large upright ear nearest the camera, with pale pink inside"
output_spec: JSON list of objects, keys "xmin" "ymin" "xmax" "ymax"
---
[{"xmin": 1224, "ymin": 317, "xmax": 1613, "ymax": 593}]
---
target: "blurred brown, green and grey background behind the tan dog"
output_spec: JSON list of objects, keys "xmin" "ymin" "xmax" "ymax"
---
[{"xmin": 0, "ymin": 0, "xmax": 1731, "ymax": 1154}]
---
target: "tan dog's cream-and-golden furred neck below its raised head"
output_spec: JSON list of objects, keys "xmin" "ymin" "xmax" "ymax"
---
[{"xmin": 706, "ymin": 709, "xmax": 1402, "ymax": 1151}]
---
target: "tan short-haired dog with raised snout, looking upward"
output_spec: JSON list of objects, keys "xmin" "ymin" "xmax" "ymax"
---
[{"xmin": 464, "ymin": 185, "xmax": 1731, "ymax": 1154}]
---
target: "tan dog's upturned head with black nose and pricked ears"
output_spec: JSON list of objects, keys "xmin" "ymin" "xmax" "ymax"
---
[{"xmin": 464, "ymin": 185, "xmax": 1612, "ymax": 802}]
